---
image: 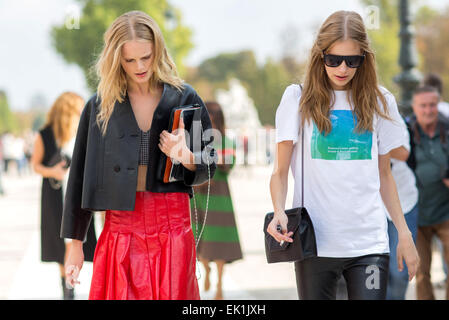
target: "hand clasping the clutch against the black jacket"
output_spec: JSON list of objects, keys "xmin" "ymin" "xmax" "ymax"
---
[{"xmin": 159, "ymin": 118, "xmax": 192, "ymax": 164}]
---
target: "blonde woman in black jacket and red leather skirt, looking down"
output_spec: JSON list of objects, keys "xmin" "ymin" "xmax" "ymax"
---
[{"xmin": 61, "ymin": 11, "xmax": 216, "ymax": 300}]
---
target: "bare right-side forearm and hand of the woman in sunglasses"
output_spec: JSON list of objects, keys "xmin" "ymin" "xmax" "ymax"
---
[{"xmin": 379, "ymin": 154, "xmax": 419, "ymax": 281}]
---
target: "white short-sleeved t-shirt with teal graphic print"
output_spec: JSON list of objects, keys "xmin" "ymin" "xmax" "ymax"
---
[{"xmin": 276, "ymin": 85, "xmax": 405, "ymax": 257}]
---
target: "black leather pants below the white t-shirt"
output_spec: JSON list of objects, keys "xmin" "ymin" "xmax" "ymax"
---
[{"xmin": 295, "ymin": 254, "xmax": 390, "ymax": 300}]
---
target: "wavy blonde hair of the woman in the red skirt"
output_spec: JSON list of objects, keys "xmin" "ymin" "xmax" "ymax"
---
[{"xmin": 95, "ymin": 11, "xmax": 183, "ymax": 135}]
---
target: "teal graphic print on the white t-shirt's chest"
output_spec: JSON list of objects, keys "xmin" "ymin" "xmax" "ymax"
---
[{"xmin": 310, "ymin": 110, "xmax": 373, "ymax": 160}]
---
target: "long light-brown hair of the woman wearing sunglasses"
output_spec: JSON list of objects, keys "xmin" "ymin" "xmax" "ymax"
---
[{"xmin": 300, "ymin": 11, "xmax": 390, "ymax": 134}]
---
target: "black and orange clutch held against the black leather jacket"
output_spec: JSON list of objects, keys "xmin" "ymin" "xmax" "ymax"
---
[{"xmin": 157, "ymin": 104, "xmax": 202, "ymax": 183}]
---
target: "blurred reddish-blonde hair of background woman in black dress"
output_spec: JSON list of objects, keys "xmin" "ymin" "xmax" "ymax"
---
[{"xmin": 44, "ymin": 92, "xmax": 84, "ymax": 147}]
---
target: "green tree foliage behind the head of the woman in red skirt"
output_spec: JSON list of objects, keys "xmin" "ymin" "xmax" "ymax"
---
[{"xmin": 51, "ymin": 0, "xmax": 192, "ymax": 91}]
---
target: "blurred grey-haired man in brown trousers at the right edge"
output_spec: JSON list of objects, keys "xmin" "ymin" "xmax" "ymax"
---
[{"xmin": 408, "ymin": 86, "xmax": 449, "ymax": 300}]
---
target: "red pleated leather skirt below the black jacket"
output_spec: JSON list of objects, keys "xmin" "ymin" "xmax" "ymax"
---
[{"xmin": 89, "ymin": 191, "xmax": 200, "ymax": 300}]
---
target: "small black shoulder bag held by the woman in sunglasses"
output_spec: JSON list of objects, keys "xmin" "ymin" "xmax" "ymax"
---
[{"xmin": 264, "ymin": 207, "xmax": 317, "ymax": 263}]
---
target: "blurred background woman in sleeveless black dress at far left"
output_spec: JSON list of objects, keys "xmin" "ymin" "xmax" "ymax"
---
[{"xmin": 31, "ymin": 92, "xmax": 97, "ymax": 300}]
